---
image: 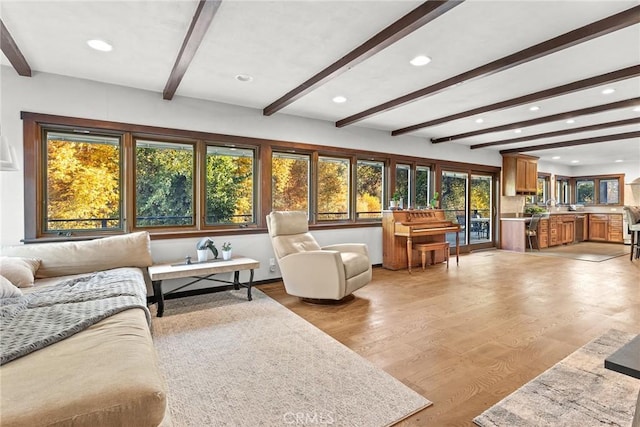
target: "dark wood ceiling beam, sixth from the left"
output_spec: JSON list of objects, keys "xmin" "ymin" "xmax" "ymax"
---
[{"xmin": 431, "ymin": 98, "xmax": 640, "ymax": 144}]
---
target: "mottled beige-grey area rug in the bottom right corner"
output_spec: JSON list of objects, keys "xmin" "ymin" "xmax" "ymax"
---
[{"xmin": 473, "ymin": 330, "xmax": 640, "ymax": 427}]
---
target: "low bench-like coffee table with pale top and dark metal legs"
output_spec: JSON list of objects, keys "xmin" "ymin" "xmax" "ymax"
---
[{"xmin": 148, "ymin": 257, "xmax": 260, "ymax": 317}]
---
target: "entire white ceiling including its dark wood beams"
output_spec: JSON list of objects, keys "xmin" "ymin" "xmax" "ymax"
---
[{"xmin": 1, "ymin": 0, "xmax": 640, "ymax": 169}]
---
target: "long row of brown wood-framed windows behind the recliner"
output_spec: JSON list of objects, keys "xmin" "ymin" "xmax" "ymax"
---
[{"xmin": 22, "ymin": 112, "xmax": 499, "ymax": 242}]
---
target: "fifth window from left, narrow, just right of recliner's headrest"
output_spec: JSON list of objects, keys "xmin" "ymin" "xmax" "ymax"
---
[{"xmin": 317, "ymin": 157, "xmax": 349, "ymax": 221}]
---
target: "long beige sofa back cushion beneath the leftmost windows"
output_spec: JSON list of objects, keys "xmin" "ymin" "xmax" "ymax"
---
[{"xmin": 2, "ymin": 231, "xmax": 153, "ymax": 278}]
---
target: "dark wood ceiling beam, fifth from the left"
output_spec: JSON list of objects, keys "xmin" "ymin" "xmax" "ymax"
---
[{"xmin": 391, "ymin": 65, "xmax": 640, "ymax": 136}]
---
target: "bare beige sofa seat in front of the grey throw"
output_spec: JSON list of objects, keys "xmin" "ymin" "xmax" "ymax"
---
[{"xmin": 0, "ymin": 309, "xmax": 166, "ymax": 427}]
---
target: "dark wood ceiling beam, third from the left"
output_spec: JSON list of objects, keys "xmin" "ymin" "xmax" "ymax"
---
[{"xmin": 262, "ymin": 0, "xmax": 464, "ymax": 116}]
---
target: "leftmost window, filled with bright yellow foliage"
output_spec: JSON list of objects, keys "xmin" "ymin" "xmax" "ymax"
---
[{"xmin": 43, "ymin": 130, "xmax": 123, "ymax": 234}]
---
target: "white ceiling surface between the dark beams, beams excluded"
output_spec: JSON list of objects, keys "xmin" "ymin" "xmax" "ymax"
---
[{"xmin": 0, "ymin": 0, "xmax": 640, "ymax": 165}]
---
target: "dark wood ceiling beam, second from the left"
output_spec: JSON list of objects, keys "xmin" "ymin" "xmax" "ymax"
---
[{"xmin": 162, "ymin": 0, "xmax": 222, "ymax": 100}]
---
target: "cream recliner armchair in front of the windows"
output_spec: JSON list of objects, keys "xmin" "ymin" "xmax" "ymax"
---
[{"xmin": 267, "ymin": 211, "xmax": 371, "ymax": 302}]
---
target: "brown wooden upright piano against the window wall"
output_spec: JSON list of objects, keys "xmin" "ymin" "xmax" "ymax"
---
[{"xmin": 382, "ymin": 209, "xmax": 460, "ymax": 270}]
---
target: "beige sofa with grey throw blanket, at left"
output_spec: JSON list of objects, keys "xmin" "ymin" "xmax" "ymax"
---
[{"xmin": 0, "ymin": 233, "xmax": 169, "ymax": 426}]
